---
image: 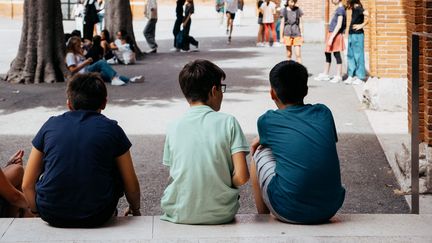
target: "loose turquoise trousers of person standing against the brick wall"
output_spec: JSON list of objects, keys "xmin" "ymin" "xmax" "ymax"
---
[{"xmin": 348, "ymin": 34, "xmax": 366, "ymax": 80}]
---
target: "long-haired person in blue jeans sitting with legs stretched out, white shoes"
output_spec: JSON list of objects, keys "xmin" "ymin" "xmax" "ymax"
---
[{"xmin": 66, "ymin": 37, "xmax": 142, "ymax": 86}]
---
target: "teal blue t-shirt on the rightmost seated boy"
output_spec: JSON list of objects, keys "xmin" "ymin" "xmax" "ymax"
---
[{"xmin": 258, "ymin": 104, "xmax": 345, "ymax": 223}]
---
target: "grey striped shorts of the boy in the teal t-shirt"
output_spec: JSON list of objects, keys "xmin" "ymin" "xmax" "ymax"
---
[{"xmin": 253, "ymin": 147, "xmax": 296, "ymax": 224}]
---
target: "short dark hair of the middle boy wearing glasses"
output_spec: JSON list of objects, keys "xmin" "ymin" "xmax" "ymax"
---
[{"xmin": 179, "ymin": 59, "xmax": 225, "ymax": 102}]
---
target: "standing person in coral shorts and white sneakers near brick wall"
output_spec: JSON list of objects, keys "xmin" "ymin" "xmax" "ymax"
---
[{"xmin": 315, "ymin": 0, "xmax": 346, "ymax": 83}]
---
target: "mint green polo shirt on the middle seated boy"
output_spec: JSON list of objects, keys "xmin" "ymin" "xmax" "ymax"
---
[{"xmin": 161, "ymin": 106, "xmax": 249, "ymax": 224}]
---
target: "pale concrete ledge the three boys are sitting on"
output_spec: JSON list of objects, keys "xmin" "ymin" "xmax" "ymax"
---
[{"xmin": 0, "ymin": 214, "xmax": 432, "ymax": 242}]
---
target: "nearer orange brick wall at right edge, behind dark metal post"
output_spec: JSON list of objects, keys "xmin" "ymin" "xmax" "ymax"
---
[{"xmin": 407, "ymin": 0, "xmax": 432, "ymax": 145}]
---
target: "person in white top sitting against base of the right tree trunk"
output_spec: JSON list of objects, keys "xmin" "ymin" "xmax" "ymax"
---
[{"xmin": 110, "ymin": 30, "xmax": 136, "ymax": 65}]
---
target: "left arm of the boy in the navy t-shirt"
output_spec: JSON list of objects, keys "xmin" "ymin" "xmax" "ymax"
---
[{"xmin": 22, "ymin": 147, "xmax": 43, "ymax": 214}]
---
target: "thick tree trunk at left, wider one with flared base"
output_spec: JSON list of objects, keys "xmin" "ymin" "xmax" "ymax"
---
[{"xmin": 6, "ymin": 0, "xmax": 68, "ymax": 84}]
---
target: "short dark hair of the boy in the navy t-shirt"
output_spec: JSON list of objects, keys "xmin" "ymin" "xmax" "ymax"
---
[{"xmin": 66, "ymin": 73, "xmax": 107, "ymax": 111}]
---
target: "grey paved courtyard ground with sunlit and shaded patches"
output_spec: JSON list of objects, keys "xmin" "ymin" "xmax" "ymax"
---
[{"xmin": 0, "ymin": 4, "xmax": 409, "ymax": 215}]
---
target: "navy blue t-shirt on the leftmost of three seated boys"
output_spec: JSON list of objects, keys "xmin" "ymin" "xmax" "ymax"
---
[{"xmin": 32, "ymin": 110, "xmax": 131, "ymax": 219}]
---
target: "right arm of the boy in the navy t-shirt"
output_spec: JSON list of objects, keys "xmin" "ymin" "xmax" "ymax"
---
[{"xmin": 116, "ymin": 150, "xmax": 141, "ymax": 216}]
